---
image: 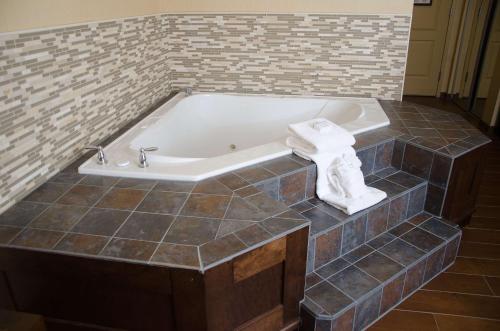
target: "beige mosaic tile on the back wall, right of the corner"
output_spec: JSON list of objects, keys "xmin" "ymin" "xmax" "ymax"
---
[{"xmin": 168, "ymin": 14, "xmax": 410, "ymax": 100}]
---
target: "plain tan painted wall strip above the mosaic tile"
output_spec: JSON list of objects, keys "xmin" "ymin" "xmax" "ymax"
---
[{"xmin": 0, "ymin": 0, "xmax": 413, "ymax": 32}]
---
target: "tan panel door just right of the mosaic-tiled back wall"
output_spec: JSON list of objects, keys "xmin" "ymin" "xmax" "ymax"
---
[{"xmin": 404, "ymin": 0, "xmax": 452, "ymax": 96}]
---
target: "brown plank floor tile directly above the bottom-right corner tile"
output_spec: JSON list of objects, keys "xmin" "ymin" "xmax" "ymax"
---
[{"xmin": 398, "ymin": 290, "xmax": 500, "ymax": 319}]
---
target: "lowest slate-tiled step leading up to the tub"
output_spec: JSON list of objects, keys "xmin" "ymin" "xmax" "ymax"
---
[{"xmin": 302, "ymin": 213, "xmax": 461, "ymax": 320}]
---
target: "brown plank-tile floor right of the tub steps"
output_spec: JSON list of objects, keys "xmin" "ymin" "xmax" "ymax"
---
[{"xmin": 369, "ymin": 109, "xmax": 500, "ymax": 331}]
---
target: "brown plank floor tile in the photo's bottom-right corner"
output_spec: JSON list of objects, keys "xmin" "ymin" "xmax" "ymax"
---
[{"xmin": 434, "ymin": 314, "xmax": 500, "ymax": 331}]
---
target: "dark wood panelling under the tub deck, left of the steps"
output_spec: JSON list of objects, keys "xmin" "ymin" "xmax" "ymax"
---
[{"xmin": 0, "ymin": 228, "xmax": 308, "ymax": 331}]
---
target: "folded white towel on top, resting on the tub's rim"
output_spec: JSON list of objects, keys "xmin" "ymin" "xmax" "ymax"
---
[{"xmin": 287, "ymin": 118, "xmax": 356, "ymax": 154}]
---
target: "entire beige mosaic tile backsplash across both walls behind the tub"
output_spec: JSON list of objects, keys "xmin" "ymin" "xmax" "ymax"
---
[{"xmin": 0, "ymin": 14, "xmax": 410, "ymax": 213}]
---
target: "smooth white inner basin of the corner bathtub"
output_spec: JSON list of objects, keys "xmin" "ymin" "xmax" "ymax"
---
[{"xmin": 130, "ymin": 94, "xmax": 363, "ymax": 161}]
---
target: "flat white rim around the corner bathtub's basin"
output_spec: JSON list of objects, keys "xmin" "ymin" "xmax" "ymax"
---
[{"xmin": 78, "ymin": 91, "xmax": 390, "ymax": 181}]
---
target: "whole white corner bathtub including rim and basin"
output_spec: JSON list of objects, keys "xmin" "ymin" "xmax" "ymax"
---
[{"xmin": 79, "ymin": 93, "xmax": 389, "ymax": 181}]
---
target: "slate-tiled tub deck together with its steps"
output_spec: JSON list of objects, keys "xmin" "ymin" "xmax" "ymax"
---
[{"xmin": 0, "ymin": 97, "xmax": 489, "ymax": 330}]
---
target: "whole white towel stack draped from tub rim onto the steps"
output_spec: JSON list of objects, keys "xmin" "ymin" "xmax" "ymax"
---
[{"xmin": 287, "ymin": 118, "xmax": 387, "ymax": 215}]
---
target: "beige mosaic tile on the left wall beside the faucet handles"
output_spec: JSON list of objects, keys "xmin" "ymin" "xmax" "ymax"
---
[{"xmin": 0, "ymin": 16, "xmax": 170, "ymax": 212}]
